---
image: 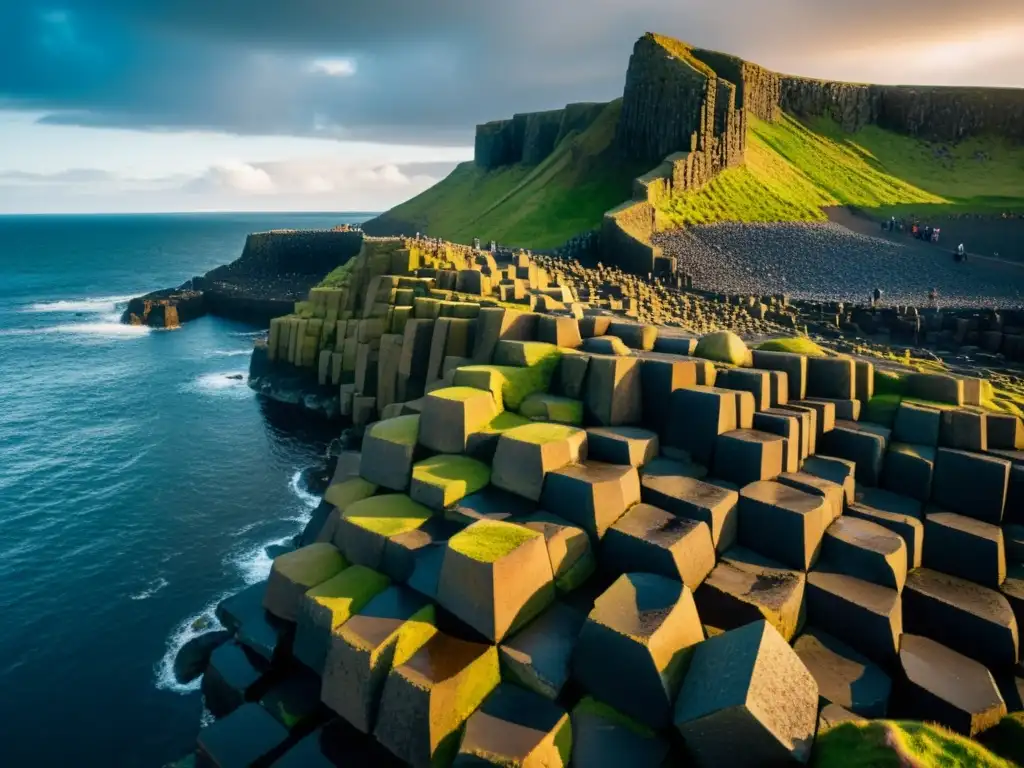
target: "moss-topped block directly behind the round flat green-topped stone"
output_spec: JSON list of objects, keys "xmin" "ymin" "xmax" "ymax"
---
[{"xmin": 419, "ymin": 387, "xmax": 499, "ymax": 456}]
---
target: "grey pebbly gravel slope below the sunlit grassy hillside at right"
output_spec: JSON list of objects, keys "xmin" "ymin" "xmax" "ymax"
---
[{"xmin": 653, "ymin": 222, "xmax": 1024, "ymax": 308}]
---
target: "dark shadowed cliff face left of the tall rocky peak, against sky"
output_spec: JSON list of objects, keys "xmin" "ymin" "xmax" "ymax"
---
[{"xmin": 473, "ymin": 103, "xmax": 607, "ymax": 169}]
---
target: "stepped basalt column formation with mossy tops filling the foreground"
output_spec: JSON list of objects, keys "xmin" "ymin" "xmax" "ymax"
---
[{"xmin": 182, "ymin": 230, "xmax": 1024, "ymax": 766}]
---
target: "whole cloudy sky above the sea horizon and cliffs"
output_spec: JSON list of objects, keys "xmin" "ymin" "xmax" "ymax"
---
[{"xmin": 0, "ymin": 0, "xmax": 1024, "ymax": 213}]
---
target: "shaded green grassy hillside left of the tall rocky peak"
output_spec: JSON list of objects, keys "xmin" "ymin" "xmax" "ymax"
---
[{"xmin": 369, "ymin": 100, "xmax": 648, "ymax": 249}]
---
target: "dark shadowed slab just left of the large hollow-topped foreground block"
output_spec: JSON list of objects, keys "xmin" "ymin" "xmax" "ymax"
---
[{"xmin": 498, "ymin": 602, "xmax": 587, "ymax": 700}]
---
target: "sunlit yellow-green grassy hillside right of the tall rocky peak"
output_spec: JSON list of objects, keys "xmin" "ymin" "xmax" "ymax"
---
[{"xmin": 662, "ymin": 116, "xmax": 1024, "ymax": 225}]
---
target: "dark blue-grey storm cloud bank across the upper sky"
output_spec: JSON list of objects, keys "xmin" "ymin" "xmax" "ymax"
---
[{"xmin": 0, "ymin": 0, "xmax": 1024, "ymax": 144}]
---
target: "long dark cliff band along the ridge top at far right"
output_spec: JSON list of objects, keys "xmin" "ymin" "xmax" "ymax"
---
[{"xmin": 780, "ymin": 77, "xmax": 1024, "ymax": 142}]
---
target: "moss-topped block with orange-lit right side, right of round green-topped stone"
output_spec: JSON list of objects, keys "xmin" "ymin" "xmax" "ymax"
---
[{"xmin": 490, "ymin": 424, "xmax": 587, "ymax": 501}]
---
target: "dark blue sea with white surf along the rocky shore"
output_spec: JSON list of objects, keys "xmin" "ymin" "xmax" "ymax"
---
[{"xmin": 0, "ymin": 214, "xmax": 366, "ymax": 768}]
